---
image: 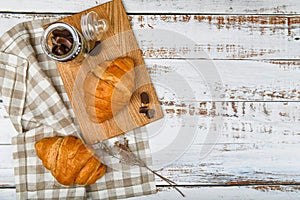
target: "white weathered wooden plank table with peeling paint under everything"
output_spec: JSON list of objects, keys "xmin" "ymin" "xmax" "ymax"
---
[{"xmin": 0, "ymin": 0, "xmax": 300, "ymax": 200}]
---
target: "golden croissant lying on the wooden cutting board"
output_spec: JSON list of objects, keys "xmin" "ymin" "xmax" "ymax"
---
[{"xmin": 83, "ymin": 57, "xmax": 135, "ymax": 123}]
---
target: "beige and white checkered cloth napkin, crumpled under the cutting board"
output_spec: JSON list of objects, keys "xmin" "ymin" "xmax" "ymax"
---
[{"xmin": 0, "ymin": 19, "xmax": 156, "ymax": 199}]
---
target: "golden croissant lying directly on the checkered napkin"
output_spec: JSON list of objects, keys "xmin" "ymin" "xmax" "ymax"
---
[{"xmin": 35, "ymin": 136, "xmax": 106, "ymax": 186}]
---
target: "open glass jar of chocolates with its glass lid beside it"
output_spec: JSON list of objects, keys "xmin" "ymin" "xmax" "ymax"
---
[{"xmin": 41, "ymin": 11, "xmax": 109, "ymax": 63}]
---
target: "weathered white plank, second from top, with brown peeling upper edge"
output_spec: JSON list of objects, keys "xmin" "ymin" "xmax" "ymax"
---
[{"xmin": 0, "ymin": 14, "xmax": 300, "ymax": 59}]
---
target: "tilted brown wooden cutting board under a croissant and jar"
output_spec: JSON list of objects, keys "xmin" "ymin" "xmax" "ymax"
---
[{"xmin": 49, "ymin": 0, "xmax": 163, "ymax": 144}]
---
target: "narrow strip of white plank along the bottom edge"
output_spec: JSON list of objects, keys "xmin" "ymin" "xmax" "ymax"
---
[{"xmin": 0, "ymin": 185, "xmax": 300, "ymax": 200}]
